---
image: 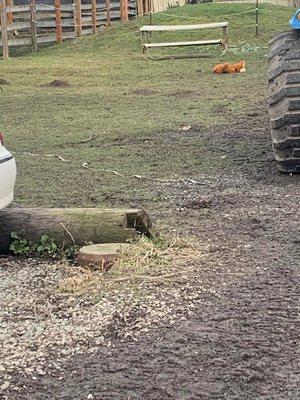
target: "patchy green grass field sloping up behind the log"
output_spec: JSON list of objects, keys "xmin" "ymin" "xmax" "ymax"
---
[{"xmin": 0, "ymin": 4, "xmax": 291, "ymax": 207}]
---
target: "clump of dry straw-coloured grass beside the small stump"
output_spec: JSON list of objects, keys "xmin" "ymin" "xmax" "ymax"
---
[{"xmin": 58, "ymin": 236, "xmax": 202, "ymax": 294}]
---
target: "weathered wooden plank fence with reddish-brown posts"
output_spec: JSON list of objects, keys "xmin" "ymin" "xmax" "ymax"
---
[{"xmin": 0, "ymin": 0, "xmax": 141, "ymax": 59}]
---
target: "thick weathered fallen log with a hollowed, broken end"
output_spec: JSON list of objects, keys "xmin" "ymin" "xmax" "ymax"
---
[{"xmin": 0, "ymin": 208, "xmax": 151, "ymax": 253}]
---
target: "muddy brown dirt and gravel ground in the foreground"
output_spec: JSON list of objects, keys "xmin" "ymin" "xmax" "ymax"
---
[{"xmin": 0, "ymin": 115, "xmax": 300, "ymax": 400}]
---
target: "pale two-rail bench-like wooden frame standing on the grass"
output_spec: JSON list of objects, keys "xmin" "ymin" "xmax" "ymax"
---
[{"xmin": 140, "ymin": 22, "xmax": 228, "ymax": 59}]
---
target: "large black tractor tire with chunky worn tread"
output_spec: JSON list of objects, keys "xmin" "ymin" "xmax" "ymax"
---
[{"xmin": 268, "ymin": 30, "xmax": 300, "ymax": 173}]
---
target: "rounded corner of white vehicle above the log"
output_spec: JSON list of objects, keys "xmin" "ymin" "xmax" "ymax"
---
[{"xmin": 0, "ymin": 133, "xmax": 17, "ymax": 210}]
